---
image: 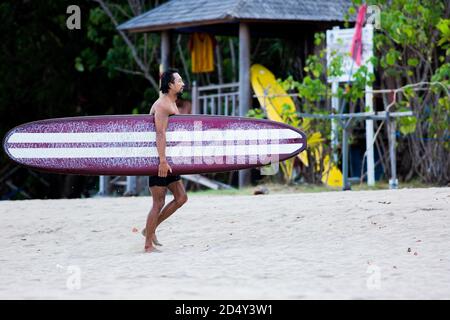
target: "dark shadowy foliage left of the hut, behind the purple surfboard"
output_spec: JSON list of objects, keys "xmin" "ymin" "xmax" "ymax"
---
[{"xmin": 0, "ymin": 0, "xmax": 155, "ymax": 198}]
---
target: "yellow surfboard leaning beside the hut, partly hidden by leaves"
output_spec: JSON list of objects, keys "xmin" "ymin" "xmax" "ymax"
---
[{"xmin": 250, "ymin": 64, "xmax": 343, "ymax": 187}]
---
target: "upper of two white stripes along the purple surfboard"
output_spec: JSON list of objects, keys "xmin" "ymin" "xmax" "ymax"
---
[{"xmin": 7, "ymin": 129, "xmax": 302, "ymax": 143}]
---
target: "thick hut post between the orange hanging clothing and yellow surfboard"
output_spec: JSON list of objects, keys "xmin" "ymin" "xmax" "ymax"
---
[{"xmin": 239, "ymin": 22, "xmax": 251, "ymax": 188}]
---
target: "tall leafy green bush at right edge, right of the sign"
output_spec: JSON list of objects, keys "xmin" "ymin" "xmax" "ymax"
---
[{"xmin": 353, "ymin": 0, "xmax": 450, "ymax": 183}]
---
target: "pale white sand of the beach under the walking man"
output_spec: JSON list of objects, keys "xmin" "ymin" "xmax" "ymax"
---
[{"xmin": 0, "ymin": 188, "xmax": 450, "ymax": 299}]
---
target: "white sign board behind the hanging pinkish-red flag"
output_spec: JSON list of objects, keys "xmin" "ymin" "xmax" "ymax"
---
[{"xmin": 327, "ymin": 24, "xmax": 373, "ymax": 82}]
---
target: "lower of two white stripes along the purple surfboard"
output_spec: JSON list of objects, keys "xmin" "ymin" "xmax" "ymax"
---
[{"xmin": 9, "ymin": 143, "xmax": 303, "ymax": 159}]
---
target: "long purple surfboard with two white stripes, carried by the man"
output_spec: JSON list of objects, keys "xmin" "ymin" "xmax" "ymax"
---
[{"xmin": 3, "ymin": 115, "xmax": 306, "ymax": 176}]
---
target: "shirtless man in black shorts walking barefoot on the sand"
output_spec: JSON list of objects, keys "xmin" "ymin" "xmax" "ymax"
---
[{"xmin": 142, "ymin": 69, "xmax": 187, "ymax": 252}]
